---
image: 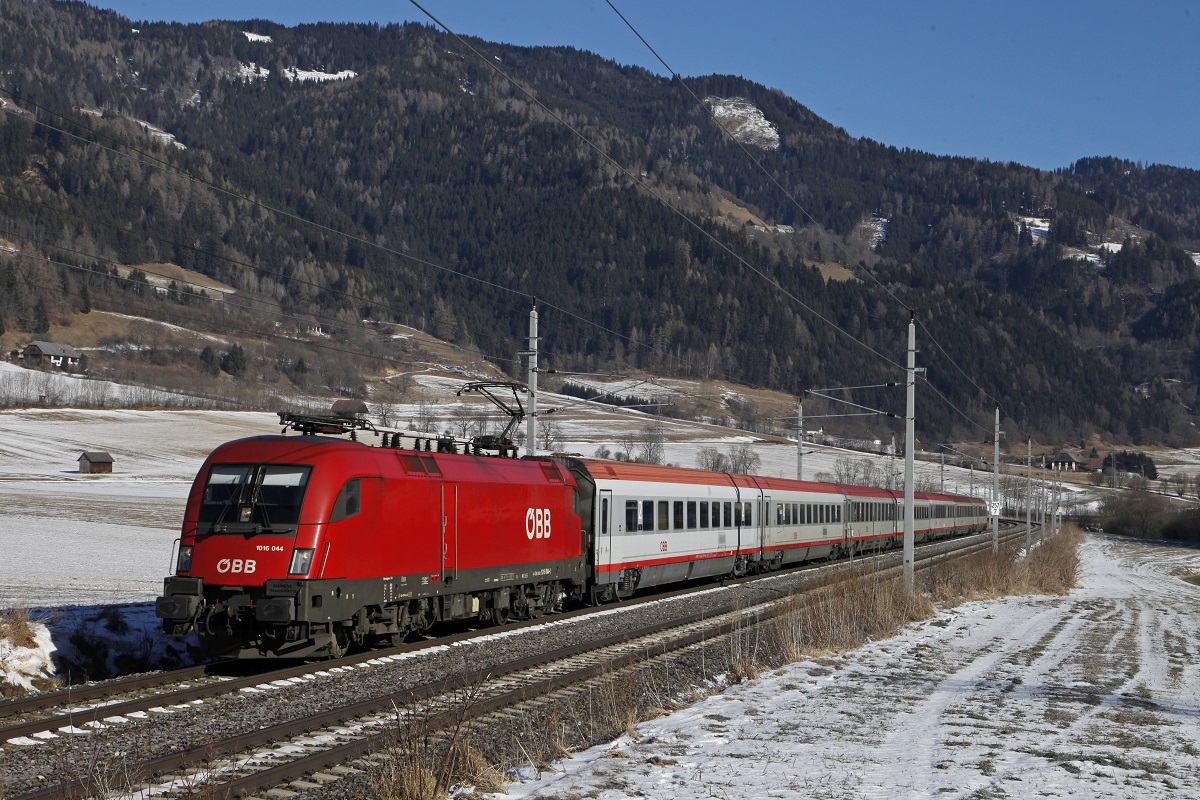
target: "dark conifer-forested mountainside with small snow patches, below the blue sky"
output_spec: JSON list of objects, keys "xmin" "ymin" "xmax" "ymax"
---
[{"xmin": 0, "ymin": 0, "xmax": 1200, "ymax": 443}]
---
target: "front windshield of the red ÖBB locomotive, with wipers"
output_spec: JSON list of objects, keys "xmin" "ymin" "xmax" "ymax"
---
[{"xmin": 199, "ymin": 464, "xmax": 312, "ymax": 534}]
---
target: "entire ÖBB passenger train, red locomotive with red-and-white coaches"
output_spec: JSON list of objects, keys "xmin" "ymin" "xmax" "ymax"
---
[{"xmin": 155, "ymin": 402, "xmax": 989, "ymax": 658}]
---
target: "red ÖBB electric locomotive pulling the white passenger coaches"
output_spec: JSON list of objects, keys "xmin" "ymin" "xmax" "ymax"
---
[{"xmin": 156, "ymin": 407, "xmax": 586, "ymax": 657}]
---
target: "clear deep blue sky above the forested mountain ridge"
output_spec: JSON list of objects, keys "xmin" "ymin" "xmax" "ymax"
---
[{"xmin": 90, "ymin": 0, "xmax": 1200, "ymax": 169}]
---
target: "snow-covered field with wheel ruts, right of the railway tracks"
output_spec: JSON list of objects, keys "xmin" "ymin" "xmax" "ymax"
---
[{"xmin": 494, "ymin": 537, "xmax": 1200, "ymax": 800}]
